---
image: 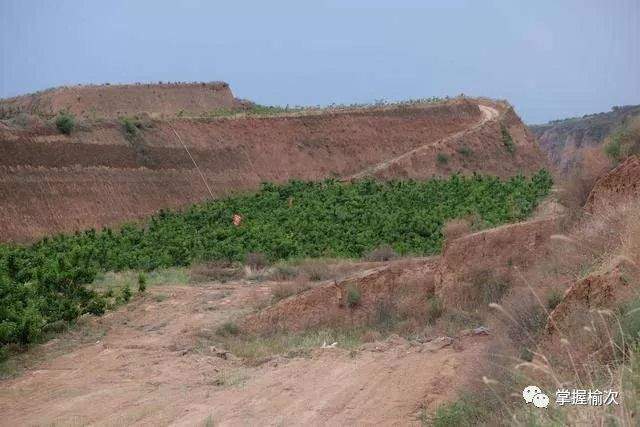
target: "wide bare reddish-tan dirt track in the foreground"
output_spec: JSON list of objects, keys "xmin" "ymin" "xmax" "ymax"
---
[{"xmin": 0, "ymin": 283, "xmax": 487, "ymax": 426}]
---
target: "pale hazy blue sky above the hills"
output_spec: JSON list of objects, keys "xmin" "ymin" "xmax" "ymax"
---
[{"xmin": 0, "ymin": 0, "xmax": 640, "ymax": 123}]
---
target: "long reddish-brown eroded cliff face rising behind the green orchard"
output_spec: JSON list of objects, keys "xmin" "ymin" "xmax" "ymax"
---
[{"xmin": 0, "ymin": 94, "xmax": 546, "ymax": 242}]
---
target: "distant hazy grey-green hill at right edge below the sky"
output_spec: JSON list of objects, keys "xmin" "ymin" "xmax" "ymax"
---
[{"xmin": 529, "ymin": 105, "xmax": 640, "ymax": 170}]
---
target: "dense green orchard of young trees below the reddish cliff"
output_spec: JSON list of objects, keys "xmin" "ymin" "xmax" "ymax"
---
[{"xmin": 0, "ymin": 170, "xmax": 552, "ymax": 346}]
